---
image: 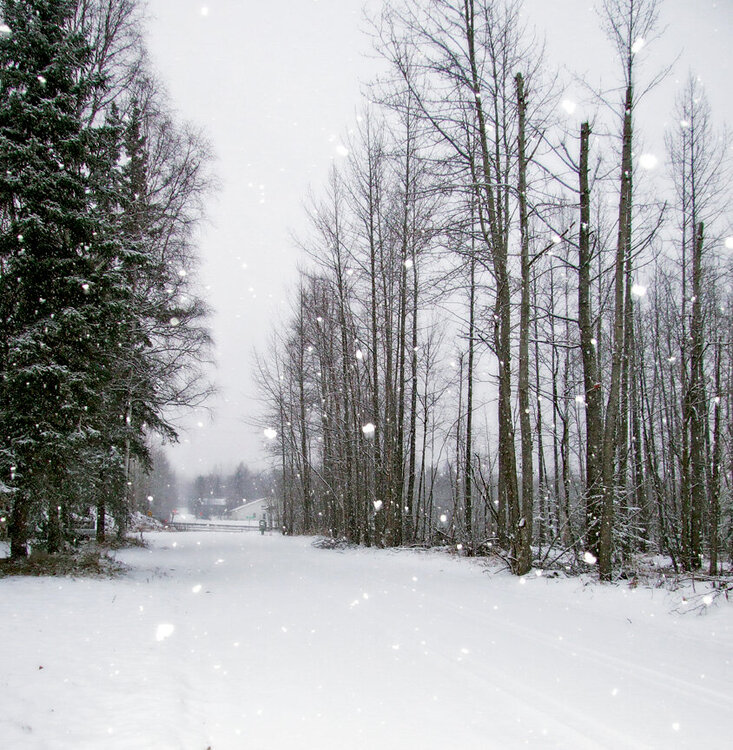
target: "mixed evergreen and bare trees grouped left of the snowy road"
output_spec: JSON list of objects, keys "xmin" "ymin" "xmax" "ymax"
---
[{"xmin": 0, "ymin": 0, "xmax": 212, "ymax": 558}]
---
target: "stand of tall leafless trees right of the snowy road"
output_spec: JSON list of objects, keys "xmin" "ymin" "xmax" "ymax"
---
[{"xmin": 258, "ymin": 0, "xmax": 733, "ymax": 580}]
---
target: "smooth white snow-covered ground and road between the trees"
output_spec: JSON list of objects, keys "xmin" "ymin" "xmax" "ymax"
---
[{"xmin": 0, "ymin": 532, "xmax": 733, "ymax": 750}]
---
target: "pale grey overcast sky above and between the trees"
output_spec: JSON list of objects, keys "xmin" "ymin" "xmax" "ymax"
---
[{"xmin": 147, "ymin": 0, "xmax": 733, "ymax": 476}]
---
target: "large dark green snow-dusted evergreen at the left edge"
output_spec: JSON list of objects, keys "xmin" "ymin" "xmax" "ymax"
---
[{"xmin": 0, "ymin": 0, "xmax": 124, "ymax": 557}]
